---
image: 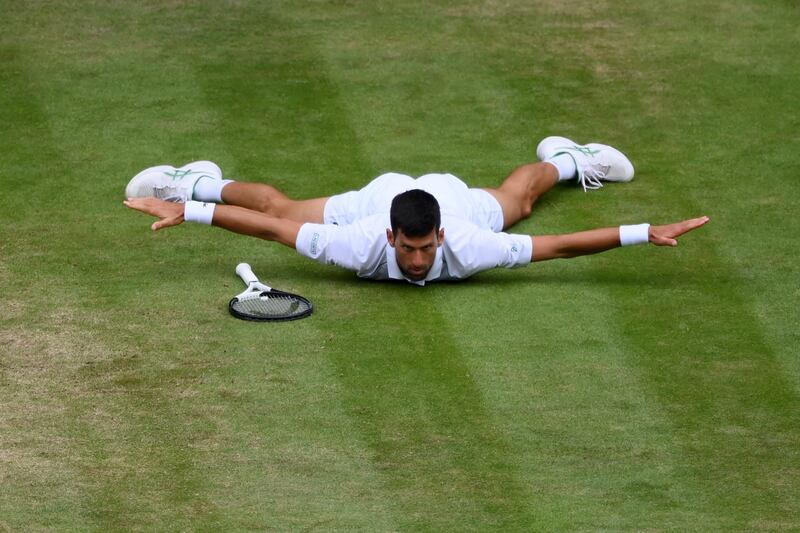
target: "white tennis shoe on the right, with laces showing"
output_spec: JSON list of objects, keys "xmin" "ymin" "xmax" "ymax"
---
[{"xmin": 536, "ymin": 137, "xmax": 634, "ymax": 191}]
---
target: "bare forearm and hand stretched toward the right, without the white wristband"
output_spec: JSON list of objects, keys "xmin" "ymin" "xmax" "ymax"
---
[{"xmin": 531, "ymin": 217, "xmax": 709, "ymax": 261}]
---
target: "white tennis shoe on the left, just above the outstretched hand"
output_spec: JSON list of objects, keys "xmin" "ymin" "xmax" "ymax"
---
[{"xmin": 125, "ymin": 161, "xmax": 222, "ymax": 203}]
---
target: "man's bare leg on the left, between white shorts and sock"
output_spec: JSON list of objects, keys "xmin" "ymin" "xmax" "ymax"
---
[{"xmin": 222, "ymin": 181, "xmax": 328, "ymax": 224}]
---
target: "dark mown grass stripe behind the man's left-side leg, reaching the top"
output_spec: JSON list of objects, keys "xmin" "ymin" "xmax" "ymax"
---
[{"xmin": 176, "ymin": 5, "xmax": 372, "ymax": 195}]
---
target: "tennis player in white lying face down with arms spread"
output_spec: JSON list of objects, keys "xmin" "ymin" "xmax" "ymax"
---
[{"xmin": 124, "ymin": 137, "xmax": 708, "ymax": 285}]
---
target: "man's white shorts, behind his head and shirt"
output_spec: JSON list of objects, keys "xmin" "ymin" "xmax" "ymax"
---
[{"xmin": 324, "ymin": 172, "xmax": 503, "ymax": 232}]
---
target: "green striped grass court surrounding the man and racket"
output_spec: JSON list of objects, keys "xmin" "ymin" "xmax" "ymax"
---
[{"xmin": 0, "ymin": 0, "xmax": 800, "ymax": 531}]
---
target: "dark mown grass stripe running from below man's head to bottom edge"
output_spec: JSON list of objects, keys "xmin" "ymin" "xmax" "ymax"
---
[{"xmin": 328, "ymin": 286, "xmax": 535, "ymax": 530}]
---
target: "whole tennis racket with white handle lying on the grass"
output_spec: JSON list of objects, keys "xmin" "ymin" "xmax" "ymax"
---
[{"xmin": 228, "ymin": 263, "xmax": 314, "ymax": 322}]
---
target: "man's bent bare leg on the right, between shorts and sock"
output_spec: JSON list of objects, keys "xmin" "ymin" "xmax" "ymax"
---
[{"xmin": 485, "ymin": 162, "xmax": 558, "ymax": 229}]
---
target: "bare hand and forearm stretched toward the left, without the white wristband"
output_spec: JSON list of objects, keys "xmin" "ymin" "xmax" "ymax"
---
[{"xmin": 124, "ymin": 198, "xmax": 303, "ymax": 248}]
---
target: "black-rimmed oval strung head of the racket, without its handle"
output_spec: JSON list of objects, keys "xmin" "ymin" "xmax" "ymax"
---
[{"xmin": 228, "ymin": 289, "xmax": 314, "ymax": 322}]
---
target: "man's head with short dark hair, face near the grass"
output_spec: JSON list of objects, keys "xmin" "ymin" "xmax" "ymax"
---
[{"xmin": 386, "ymin": 189, "xmax": 444, "ymax": 281}]
